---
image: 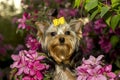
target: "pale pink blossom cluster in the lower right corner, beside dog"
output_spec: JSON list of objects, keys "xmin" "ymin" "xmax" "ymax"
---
[{"xmin": 76, "ymin": 55, "xmax": 116, "ymax": 80}]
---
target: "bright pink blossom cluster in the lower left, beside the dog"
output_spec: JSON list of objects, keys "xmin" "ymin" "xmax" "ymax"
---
[{"xmin": 10, "ymin": 50, "xmax": 48, "ymax": 80}]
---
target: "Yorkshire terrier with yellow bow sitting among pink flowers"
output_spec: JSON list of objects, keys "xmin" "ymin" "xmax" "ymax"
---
[{"xmin": 36, "ymin": 17, "xmax": 88, "ymax": 80}]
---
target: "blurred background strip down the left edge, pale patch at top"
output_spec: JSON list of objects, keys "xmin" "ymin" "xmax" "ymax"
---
[{"xmin": 0, "ymin": 0, "xmax": 24, "ymax": 80}]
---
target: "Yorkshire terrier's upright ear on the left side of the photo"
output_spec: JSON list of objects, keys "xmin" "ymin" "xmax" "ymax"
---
[{"xmin": 35, "ymin": 22, "xmax": 49, "ymax": 40}]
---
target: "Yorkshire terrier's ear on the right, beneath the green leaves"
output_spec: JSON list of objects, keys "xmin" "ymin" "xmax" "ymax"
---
[{"xmin": 69, "ymin": 18, "xmax": 89, "ymax": 39}]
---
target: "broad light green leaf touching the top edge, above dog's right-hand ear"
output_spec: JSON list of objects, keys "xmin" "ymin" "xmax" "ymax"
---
[{"xmin": 85, "ymin": 0, "xmax": 98, "ymax": 12}]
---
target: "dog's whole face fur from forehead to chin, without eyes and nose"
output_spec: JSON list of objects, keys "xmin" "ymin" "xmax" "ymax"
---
[{"xmin": 44, "ymin": 25, "xmax": 77, "ymax": 64}]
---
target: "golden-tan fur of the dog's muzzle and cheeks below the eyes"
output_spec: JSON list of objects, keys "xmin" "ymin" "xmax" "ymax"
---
[{"xmin": 46, "ymin": 35, "xmax": 76, "ymax": 63}]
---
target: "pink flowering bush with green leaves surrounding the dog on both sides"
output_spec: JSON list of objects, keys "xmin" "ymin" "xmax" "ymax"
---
[{"xmin": 10, "ymin": 0, "xmax": 120, "ymax": 80}]
